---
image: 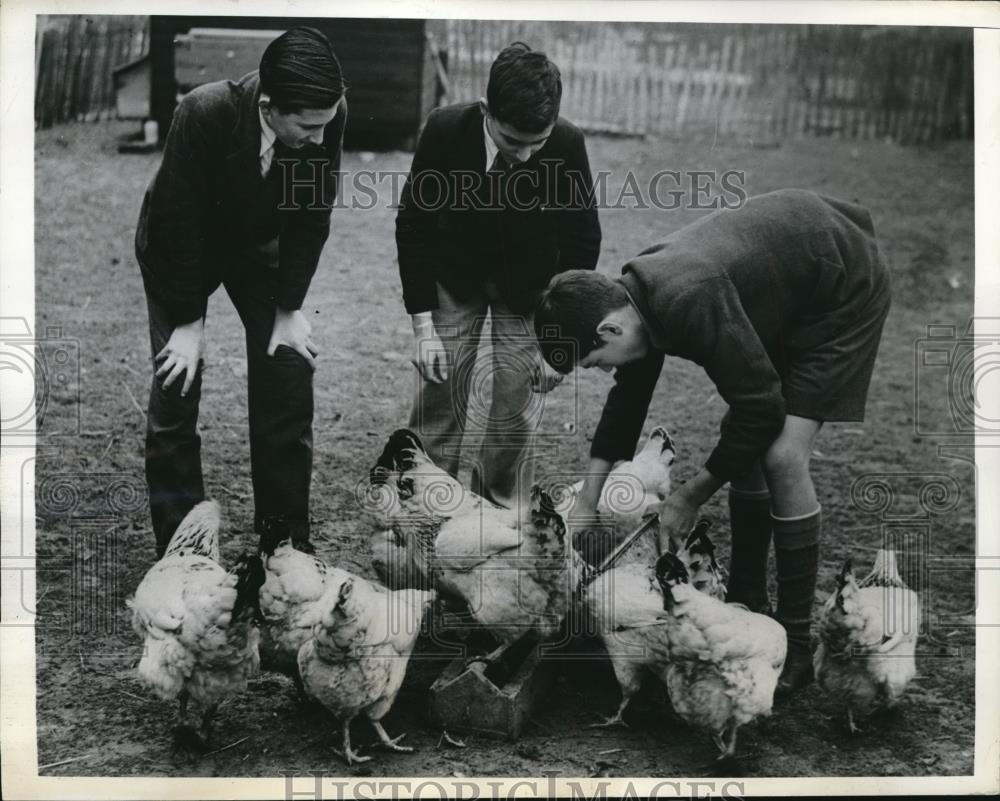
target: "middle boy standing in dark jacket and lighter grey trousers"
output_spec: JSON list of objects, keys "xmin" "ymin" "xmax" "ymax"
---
[{"xmin": 396, "ymin": 42, "xmax": 601, "ymax": 508}]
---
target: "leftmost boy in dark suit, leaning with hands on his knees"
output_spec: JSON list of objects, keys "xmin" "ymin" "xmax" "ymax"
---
[{"xmin": 135, "ymin": 28, "xmax": 347, "ymax": 554}]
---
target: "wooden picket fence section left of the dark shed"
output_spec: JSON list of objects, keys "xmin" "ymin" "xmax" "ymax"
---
[{"xmin": 35, "ymin": 15, "xmax": 149, "ymax": 128}]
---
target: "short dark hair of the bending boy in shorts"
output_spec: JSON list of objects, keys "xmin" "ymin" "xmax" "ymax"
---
[{"xmin": 535, "ymin": 270, "xmax": 628, "ymax": 374}]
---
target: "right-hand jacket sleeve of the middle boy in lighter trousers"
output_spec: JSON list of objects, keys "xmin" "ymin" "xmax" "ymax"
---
[{"xmin": 559, "ymin": 132, "xmax": 601, "ymax": 272}]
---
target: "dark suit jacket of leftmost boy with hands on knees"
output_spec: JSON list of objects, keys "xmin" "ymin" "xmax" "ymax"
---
[{"xmin": 135, "ymin": 72, "xmax": 347, "ymax": 325}]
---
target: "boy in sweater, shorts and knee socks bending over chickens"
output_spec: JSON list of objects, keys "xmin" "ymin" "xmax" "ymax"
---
[{"xmin": 535, "ymin": 190, "xmax": 889, "ymax": 694}]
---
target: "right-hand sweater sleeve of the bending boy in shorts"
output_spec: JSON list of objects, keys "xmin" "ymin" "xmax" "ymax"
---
[{"xmin": 666, "ymin": 277, "xmax": 785, "ymax": 481}]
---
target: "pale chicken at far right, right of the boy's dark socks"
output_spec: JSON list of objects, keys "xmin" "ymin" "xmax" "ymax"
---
[{"xmin": 813, "ymin": 548, "xmax": 920, "ymax": 732}]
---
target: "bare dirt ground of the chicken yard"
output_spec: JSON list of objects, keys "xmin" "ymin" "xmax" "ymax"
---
[{"xmin": 35, "ymin": 124, "xmax": 975, "ymax": 777}]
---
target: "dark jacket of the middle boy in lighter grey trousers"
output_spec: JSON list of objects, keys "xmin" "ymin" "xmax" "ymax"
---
[{"xmin": 396, "ymin": 103, "xmax": 601, "ymax": 314}]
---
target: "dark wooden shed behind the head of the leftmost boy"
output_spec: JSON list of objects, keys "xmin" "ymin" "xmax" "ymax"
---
[{"xmin": 149, "ymin": 16, "xmax": 444, "ymax": 150}]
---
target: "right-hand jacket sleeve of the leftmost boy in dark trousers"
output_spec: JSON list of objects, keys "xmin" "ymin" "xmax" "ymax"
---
[{"xmin": 276, "ymin": 97, "xmax": 347, "ymax": 311}]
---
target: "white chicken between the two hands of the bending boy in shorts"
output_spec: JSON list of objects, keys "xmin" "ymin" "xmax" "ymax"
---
[{"xmin": 571, "ymin": 426, "xmax": 676, "ymax": 566}]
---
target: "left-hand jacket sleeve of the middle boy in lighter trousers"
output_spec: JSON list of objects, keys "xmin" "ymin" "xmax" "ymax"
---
[{"xmin": 396, "ymin": 112, "xmax": 447, "ymax": 314}]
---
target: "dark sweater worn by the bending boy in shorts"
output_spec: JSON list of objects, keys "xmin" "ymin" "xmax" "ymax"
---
[{"xmin": 591, "ymin": 189, "xmax": 889, "ymax": 480}]
